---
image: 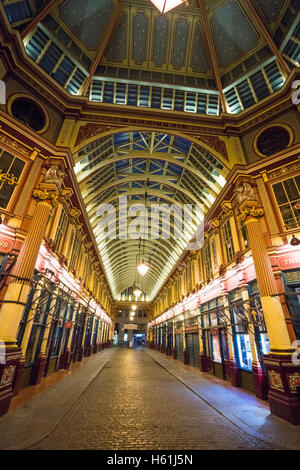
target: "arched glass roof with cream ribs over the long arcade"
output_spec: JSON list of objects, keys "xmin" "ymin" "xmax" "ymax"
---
[{"xmin": 75, "ymin": 131, "xmax": 228, "ymax": 299}]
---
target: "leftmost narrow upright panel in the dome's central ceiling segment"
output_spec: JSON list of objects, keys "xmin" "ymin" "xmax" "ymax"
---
[{"xmin": 132, "ymin": 11, "xmax": 148, "ymax": 65}]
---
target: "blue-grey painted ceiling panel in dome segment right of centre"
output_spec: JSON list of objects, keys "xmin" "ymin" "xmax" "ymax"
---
[{"xmin": 211, "ymin": 0, "xmax": 258, "ymax": 68}]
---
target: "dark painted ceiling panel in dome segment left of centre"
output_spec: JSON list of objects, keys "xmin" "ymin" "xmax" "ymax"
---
[{"xmin": 60, "ymin": 0, "xmax": 114, "ymax": 49}]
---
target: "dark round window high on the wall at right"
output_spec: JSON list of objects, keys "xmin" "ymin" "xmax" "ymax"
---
[{"xmin": 256, "ymin": 126, "xmax": 291, "ymax": 157}]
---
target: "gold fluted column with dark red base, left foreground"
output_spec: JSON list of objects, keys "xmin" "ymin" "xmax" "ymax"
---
[{"xmin": 0, "ymin": 166, "xmax": 63, "ymax": 416}]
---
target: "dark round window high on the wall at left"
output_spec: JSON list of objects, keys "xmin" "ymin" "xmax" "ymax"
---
[{"xmin": 11, "ymin": 98, "xmax": 46, "ymax": 132}]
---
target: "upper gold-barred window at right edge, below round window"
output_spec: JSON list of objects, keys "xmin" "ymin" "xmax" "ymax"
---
[{"xmin": 273, "ymin": 175, "xmax": 300, "ymax": 230}]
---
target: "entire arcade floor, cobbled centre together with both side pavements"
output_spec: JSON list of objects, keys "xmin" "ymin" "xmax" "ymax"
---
[{"xmin": 0, "ymin": 348, "xmax": 300, "ymax": 450}]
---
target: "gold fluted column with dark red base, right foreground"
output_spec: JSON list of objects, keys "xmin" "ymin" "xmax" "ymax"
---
[{"xmin": 237, "ymin": 182, "xmax": 300, "ymax": 424}]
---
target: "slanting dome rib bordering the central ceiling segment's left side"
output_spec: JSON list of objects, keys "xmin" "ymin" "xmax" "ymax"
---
[{"xmin": 81, "ymin": 0, "xmax": 125, "ymax": 96}]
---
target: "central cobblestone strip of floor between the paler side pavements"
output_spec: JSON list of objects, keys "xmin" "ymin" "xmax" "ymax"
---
[{"xmin": 31, "ymin": 348, "xmax": 273, "ymax": 450}]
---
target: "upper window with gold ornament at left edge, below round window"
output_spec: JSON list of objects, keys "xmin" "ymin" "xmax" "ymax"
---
[{"xmin": 0, "ymin": 148, "xmax": 25, "ymax": 209}]
